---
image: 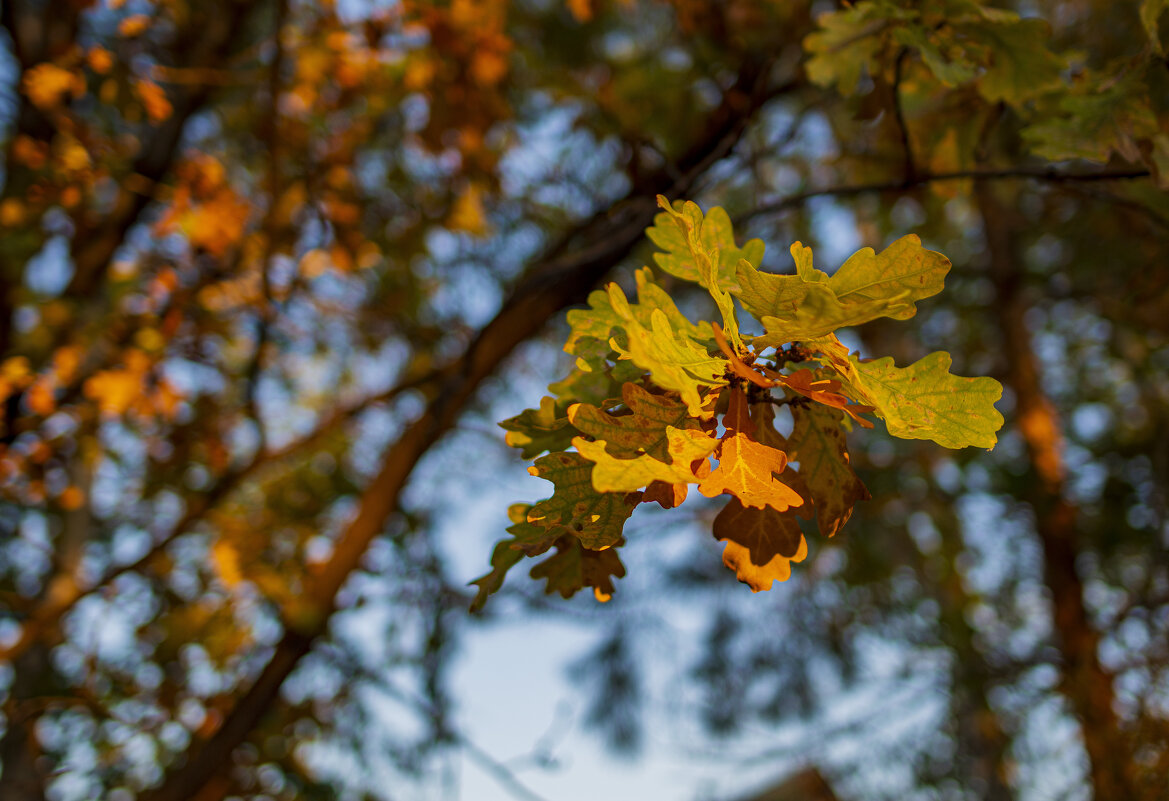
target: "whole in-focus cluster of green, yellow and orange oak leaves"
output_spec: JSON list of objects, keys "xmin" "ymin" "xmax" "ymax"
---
[{"xmin": 472, "ymin": 196, "xmax": 1003, "ymax": 608}]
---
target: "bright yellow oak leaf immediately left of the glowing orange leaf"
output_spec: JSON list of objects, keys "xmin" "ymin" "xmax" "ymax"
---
[{"xmin": 573, "ymin": 426, "xmax": 719, "ymax": 492}]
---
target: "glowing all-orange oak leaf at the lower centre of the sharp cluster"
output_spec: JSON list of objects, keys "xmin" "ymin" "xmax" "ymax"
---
[{"xmin": 698, "ymin": 434, "xmax": 803, "ymax": 512}]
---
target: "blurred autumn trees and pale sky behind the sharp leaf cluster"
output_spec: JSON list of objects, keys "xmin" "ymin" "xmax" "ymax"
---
[{"xmin": 0, "ymin": 0, "xmax": 1169, "ymax": 801}]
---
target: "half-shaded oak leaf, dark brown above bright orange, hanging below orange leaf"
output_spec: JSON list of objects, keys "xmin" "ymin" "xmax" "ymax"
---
[{"xmin": 714, "ymin": 498, "xmax": 808, "ymax": 593}]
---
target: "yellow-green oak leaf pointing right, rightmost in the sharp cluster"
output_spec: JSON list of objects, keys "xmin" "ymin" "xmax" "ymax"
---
[{"xmin": 842, "ymin": 351, "xmax": 1003, "ymax": 449}]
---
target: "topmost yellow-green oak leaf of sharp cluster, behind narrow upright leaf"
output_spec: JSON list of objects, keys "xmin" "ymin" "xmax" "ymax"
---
[{"xmin": 645, "ymin": 196, "xmax": 763, "ymax": 289}]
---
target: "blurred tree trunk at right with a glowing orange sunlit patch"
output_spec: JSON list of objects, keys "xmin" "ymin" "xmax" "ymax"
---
[{"xmin": 975, "ymin": 182, "xmax": 1141, "ymax": 801}]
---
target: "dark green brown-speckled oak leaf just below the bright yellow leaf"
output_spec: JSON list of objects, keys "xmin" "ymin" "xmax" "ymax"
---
[{"xmin": 527, "ymin": 453, "xmax": 636, "ymax": 551}]
